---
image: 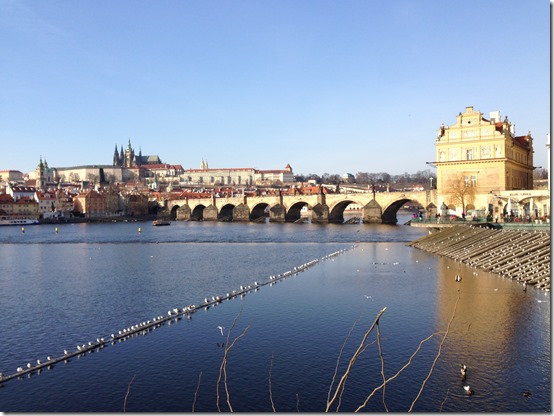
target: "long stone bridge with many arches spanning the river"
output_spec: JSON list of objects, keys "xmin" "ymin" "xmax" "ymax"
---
[{"xmin": 164, "ymin": 190, "xmax": 437, "ymax": 224}]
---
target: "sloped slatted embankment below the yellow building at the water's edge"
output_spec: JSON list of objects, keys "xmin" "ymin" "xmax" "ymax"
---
[{"xmin": 408, "ymin": 226, "xmax": 550, "ymax": 291}]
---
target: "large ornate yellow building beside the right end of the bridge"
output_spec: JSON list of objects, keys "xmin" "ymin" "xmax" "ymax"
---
[{"xmin": 434, "ymin": 107, "xmax": 542, "ymax": 216}]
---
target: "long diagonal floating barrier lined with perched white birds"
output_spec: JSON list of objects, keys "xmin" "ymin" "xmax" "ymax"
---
[{"xmin": 0, "ymin": 245, "xmax": 356, "ymax": 386}]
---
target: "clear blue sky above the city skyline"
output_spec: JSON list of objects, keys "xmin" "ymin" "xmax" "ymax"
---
[{"xmin": 0, "ymin": 0, "xmax": 551, "ymax": 175}]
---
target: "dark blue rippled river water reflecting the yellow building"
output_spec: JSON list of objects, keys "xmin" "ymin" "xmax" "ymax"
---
[{"xmin": 0, "ymin": 218, "xmax": 551, "ymax": 412}]
